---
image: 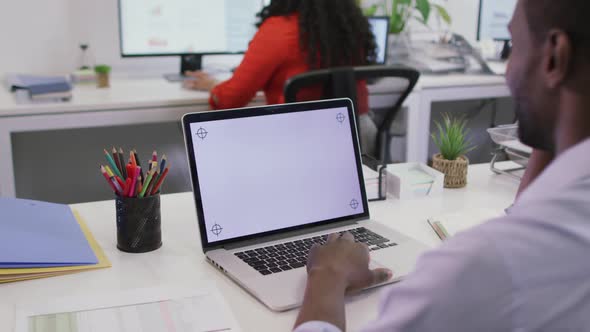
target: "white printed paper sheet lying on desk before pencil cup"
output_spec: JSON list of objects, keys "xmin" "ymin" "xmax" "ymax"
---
[{"xmin": 15, "ymin": 283, "xmax": 239, "ymax": 332}]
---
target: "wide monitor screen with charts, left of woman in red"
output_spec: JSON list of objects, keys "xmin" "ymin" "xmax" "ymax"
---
[{"xmin": 119, "ymin": 0, "xmax": 263, "ymax": 56}]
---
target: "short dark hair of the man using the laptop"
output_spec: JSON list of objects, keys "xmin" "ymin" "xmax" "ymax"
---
[{"xmin": 522, "ymin": 0, "xmax": 590, "ymax": 63}]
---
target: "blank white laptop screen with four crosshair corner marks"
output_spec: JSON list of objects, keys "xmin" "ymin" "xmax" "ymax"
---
[{"xmin": 190, "ymin": 107, "xmax": 365, "ymax": 243}]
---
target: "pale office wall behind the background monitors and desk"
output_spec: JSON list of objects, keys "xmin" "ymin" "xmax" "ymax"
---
[{"xmin": 0, "ymin": 0, "xmax": 479, "ymax": 76}]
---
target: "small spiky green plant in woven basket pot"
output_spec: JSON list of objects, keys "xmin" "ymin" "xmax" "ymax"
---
[{"xmin": 432, "ymin": 114, "xmax": 475, "ymax": 188}]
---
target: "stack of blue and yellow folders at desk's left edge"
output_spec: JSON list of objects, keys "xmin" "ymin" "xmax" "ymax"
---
[{"xmin": 0, "ymin": 198, "xmax": 110, "ymax": 283}]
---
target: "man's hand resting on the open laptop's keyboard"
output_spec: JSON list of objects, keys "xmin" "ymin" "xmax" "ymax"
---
[{"xmin": 307, "ymin": 232, "xmax": 392, "ymax": 291}]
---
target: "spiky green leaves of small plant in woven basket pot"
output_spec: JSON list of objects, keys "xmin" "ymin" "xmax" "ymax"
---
[{"xmin": 432, "ymin": 114, "xmax": 476, "ymax": 160}]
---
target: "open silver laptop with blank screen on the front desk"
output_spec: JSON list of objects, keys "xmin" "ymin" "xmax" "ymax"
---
[{"xmin": 182, "ymin": 99, "xmax": 427, "ymax": 311}]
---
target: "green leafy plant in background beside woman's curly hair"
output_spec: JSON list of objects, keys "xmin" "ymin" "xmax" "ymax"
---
[{"xmin": 358, "ymin": 0, "xmax": 452, "ymax": 34}]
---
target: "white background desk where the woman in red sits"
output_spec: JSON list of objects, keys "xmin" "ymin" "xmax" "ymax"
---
[{"xmin": 0, "ymin": 75, "xmax": 509, "ymax": 197}]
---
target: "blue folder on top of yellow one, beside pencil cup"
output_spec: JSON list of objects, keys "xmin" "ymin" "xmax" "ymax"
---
[{"xmin": 0, "ymin": 198, "xmax": 98, "ymax": 268}]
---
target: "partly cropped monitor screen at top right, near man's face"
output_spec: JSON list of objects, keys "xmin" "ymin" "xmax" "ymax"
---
[{"xmin": 477, "ymin": 0, "xmax": 517, "ymax": 40}]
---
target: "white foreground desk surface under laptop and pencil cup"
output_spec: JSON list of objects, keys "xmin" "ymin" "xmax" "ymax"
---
[{"xmin": 0, "ymin": 164, "xmax": 518, "ymax": 331}]
